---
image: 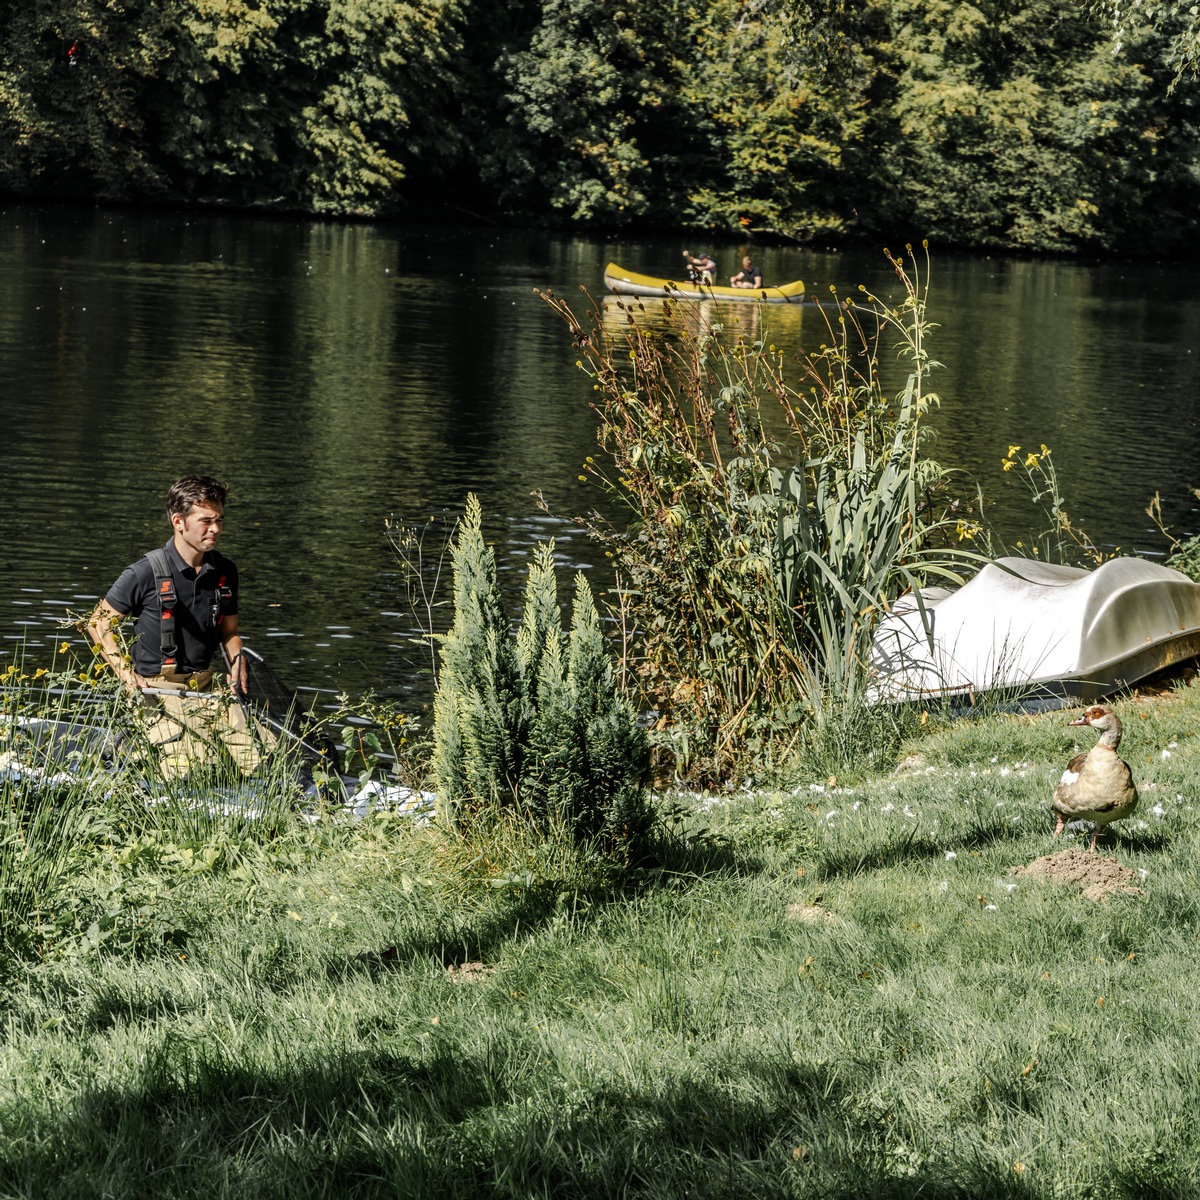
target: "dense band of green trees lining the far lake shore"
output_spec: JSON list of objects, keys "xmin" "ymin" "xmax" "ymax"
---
[{"xmin": 0, "ymin": 0, "xmax": 1200, "ymax": 252}]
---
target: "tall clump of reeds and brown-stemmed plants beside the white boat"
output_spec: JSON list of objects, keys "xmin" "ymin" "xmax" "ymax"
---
[{"xmin": 544, "ymin": 247, "xmax": 972, "ymax": 782}]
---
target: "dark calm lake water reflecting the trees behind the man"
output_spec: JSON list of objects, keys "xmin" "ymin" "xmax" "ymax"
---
[{"xmin": 0, "ymin": 204, "xmax": 1200, "ymax": 706}]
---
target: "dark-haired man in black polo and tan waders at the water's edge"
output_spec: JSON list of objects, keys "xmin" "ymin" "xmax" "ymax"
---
[{"xmin": 88, "ymin": 475, "xmax": 258, "ymax": 774}]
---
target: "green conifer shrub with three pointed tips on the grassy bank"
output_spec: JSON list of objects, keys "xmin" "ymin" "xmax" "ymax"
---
[{"xmin": 433, "ymin": 496, "xmax": 650, "ymax": 863}]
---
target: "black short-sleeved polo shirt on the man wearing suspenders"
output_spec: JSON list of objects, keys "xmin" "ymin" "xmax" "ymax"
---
[{"xmin": 104, "ymin": 538, "xmax": 238, "ymax": 676}]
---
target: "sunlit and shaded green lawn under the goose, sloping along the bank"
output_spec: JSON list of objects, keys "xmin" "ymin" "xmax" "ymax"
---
[{"xmin": 0, "ymin": 689, "xmax": 1200, "ymax": 1200}]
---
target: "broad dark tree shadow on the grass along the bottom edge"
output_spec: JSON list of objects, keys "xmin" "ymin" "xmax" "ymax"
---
[{"xmin": 0, "ymin": 1036, "xmax": 1051, "ymax": 1200}]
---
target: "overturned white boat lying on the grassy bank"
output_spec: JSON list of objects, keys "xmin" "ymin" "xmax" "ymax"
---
[{"xmin": 871, "ymin": 558, "xmax": 1200, "ymax": 702}]
